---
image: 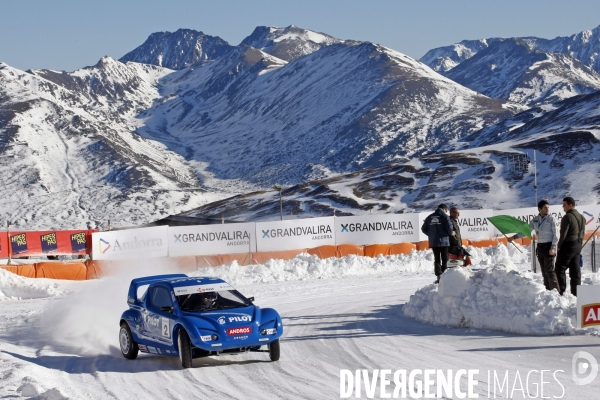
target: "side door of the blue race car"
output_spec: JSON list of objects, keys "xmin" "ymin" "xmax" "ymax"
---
[{"xmin": 144, "ymin": 285, "xmax": 174, "ymax": 345}]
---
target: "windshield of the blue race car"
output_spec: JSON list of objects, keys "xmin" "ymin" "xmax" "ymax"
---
[{"xmin": 175, "ymin": 290, "xmax": 252, "ymax": 311}]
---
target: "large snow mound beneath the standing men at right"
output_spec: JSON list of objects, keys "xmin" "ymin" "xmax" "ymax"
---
[{"xmin": 404, "ymin": 265, "xmax": 595, "ymax": 335}]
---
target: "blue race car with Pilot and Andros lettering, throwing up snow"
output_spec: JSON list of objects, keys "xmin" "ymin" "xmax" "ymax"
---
[{"xmin": 119, "ymin": 274, "xmax": 283, "ymax": 368}]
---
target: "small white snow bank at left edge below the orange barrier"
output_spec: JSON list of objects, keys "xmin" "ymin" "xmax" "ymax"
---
[{"xmin": 0, "ymin": 268, "xmax": 65, "ymax": 301}]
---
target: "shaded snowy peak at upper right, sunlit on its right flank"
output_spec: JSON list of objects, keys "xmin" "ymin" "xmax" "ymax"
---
[{"xmin": 445, "ymin": 38, "xmax": 600, "ymax": 106}]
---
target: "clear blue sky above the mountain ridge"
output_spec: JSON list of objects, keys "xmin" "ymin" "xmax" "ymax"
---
[{"xmin": 0, "ymin": 0, "xmax": 600, "ymax": 71}]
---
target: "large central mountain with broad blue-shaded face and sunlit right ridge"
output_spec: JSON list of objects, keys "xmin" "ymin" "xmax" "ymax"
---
[{"xmin": 138, "ymin": 39, "xmax": 524, "ymax": 188}]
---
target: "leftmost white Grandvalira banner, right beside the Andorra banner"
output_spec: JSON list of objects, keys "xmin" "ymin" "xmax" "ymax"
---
[{"xmin": 169, "ymin": 223, "xmax": 256, "ymax": 257}]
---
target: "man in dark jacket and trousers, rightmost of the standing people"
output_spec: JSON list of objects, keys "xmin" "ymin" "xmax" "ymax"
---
[{"xmin": 556, "ymin": 197, "xmax": 585, "ymax": 296}]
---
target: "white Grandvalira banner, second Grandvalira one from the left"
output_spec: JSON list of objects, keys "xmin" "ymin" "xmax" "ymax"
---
[{"xmin": 256, "ymin": 217, "xmax": 335, "ymax": 251}]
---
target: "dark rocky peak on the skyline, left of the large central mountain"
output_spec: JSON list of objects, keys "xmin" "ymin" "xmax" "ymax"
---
[{"xmin": 119, "ymin": 29, "xmax": 232, "ymax": 70}]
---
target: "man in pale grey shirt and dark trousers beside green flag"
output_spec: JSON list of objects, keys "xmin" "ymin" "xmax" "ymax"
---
[{"xmin": 529, "ymin": 200, "xmax": 556, "ymax": 291}]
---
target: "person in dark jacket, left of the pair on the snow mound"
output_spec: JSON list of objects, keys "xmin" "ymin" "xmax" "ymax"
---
[{"xmin": 421, "ymin": 204, "xmax": 456, "ymax": 283}]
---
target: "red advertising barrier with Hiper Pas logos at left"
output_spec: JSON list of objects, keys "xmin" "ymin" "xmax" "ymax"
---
[{"xmin": 6, "ymin": 230, "xmax": 96, "ymax": 257}]
